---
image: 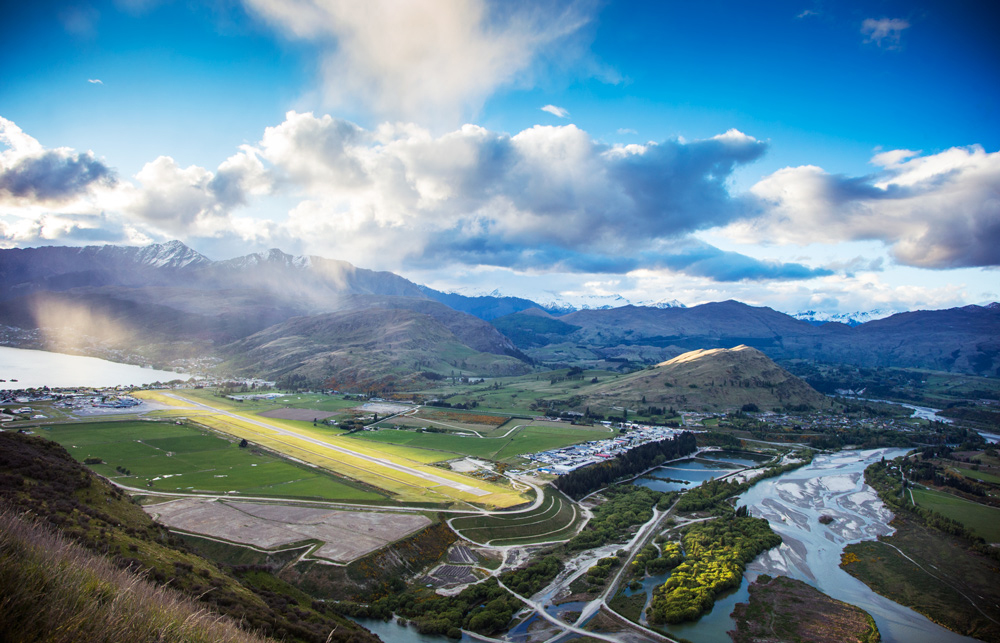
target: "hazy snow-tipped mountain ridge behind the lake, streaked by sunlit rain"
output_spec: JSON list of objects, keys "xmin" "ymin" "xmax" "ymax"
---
[{"xmin": 0, "ymin": 242, "xmax": 531, "ymax": 387}]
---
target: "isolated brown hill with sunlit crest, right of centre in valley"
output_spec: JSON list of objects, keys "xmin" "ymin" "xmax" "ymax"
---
[{"xmin": 584, "ymin": 346, "xmax": 830, "ymax": 411}]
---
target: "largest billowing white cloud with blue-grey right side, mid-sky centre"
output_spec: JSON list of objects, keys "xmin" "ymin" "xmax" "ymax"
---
[{"xmin": 246, "ymin": 112, "xmax": 766, "ymax": 270}]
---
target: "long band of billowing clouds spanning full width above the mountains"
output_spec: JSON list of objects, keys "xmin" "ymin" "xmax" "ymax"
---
[{"xmin": 0, "ymin": 112, "xmax": 1000, "ymax": 290}]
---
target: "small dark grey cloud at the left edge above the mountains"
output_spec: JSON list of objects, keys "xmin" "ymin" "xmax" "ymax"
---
[{"xmin": 0, "ymin": 150, "xmax": 115, "ymax": 201}]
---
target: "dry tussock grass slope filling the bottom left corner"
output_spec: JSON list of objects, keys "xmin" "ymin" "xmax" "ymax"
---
[{"xmin": 0, "ymin": 509, "xmax": 271, "ymax": 643}]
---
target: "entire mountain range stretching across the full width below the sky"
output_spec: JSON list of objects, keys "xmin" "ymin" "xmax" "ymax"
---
[{"xmin": 0, "ymin": 241, "xmax": 1000, "ymax": 386}]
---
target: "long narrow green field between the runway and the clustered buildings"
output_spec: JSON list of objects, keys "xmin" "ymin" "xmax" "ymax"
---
[{"xmin": 350, "ymin": 424, "xmax": 615, "ymax": 460}]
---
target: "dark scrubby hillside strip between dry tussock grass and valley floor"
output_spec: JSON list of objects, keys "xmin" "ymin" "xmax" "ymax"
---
[{"xmin": 0, "ymin": 432, "xmax": 377, "ymax": 643}]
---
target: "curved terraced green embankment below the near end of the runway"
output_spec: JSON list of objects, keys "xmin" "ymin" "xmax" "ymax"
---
[{"xmin": 451, "ymin": 487, "xmax": 582, "ymax": 546}]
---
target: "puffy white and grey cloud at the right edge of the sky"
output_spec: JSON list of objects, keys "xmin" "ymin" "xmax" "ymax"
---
[{"xmin": 727, "ymin": 146, "xmax": 1000, "ymax": 268}]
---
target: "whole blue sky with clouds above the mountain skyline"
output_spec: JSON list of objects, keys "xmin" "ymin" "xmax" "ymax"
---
[{"xmin": 0, "ymin": 0, "xmax": 1000, "ymax": 313}]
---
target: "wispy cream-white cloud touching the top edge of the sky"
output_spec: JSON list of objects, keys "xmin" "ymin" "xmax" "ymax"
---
[{"xmin": 244, "ymin": 0, "xmax": 593, "ymax": 124}]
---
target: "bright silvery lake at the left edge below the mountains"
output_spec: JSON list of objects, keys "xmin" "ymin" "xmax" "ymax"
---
[{"xmin": 0, "ymin": 346, "xmax": 191, "ymax": 390}]
